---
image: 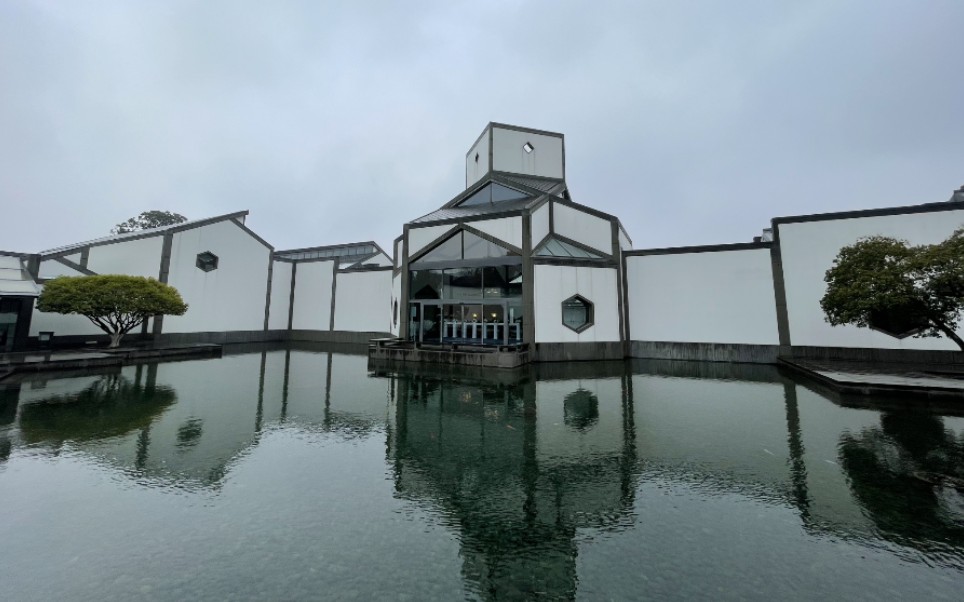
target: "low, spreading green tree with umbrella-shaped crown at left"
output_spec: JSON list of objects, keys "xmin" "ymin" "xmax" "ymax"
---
[{"xmin": 37, "ymin": 274, "xmax": 187, "ymax": 347}]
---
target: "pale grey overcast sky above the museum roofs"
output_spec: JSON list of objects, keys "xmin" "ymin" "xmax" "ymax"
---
[{"xmin": 0, "ymin": 0, "xmax": 964, "ymax": 252}]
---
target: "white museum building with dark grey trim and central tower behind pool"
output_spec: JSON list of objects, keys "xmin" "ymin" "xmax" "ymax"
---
[{"xmin": 0, "ymin": 123, "xmax": 964, "ymax": 363}]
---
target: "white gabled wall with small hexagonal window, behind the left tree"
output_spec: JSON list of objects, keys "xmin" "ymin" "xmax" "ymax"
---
[{"xmin": 164, "ymin": 221, "xmax": 271, "ymax": 333}]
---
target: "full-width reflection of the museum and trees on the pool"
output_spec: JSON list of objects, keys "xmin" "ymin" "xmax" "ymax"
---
[{"xmin": 0, "ymin": 348, "xmax": 964, "ymax": 599}]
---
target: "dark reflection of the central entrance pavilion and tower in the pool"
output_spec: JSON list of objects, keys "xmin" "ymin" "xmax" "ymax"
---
[{"xmin": 380, "ymin": 358, "xmax": 637, "ymax": 599}]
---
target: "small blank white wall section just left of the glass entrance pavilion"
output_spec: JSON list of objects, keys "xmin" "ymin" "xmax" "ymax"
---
[{"xmin": 335, "ymin": 270, "xmax": 392, "ymax": 332}]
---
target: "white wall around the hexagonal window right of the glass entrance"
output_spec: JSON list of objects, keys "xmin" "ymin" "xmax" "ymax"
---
[{"xmin": 533, "ymin": 265, "xmax": 619, "ymax": 343}]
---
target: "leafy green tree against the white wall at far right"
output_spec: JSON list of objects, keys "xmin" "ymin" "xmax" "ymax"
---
[{"xmin": 820, "ymin": 228, "xmax": 964, "ymax": 350}]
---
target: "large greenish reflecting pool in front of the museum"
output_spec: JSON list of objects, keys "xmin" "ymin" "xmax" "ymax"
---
[{"xmin": 0, "ymin": 348, "xmax": 964, "ymax": 600}]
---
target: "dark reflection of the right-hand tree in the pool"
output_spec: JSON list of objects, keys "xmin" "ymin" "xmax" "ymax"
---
[{"xmin": 839, "ymin": 409, "xmax": 964, "ymax": 552}]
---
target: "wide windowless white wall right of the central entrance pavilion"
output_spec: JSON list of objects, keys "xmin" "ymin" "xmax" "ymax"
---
[{"xmin": 626, "ymin": 249, "xmax": 780, "ymax": 345}]
